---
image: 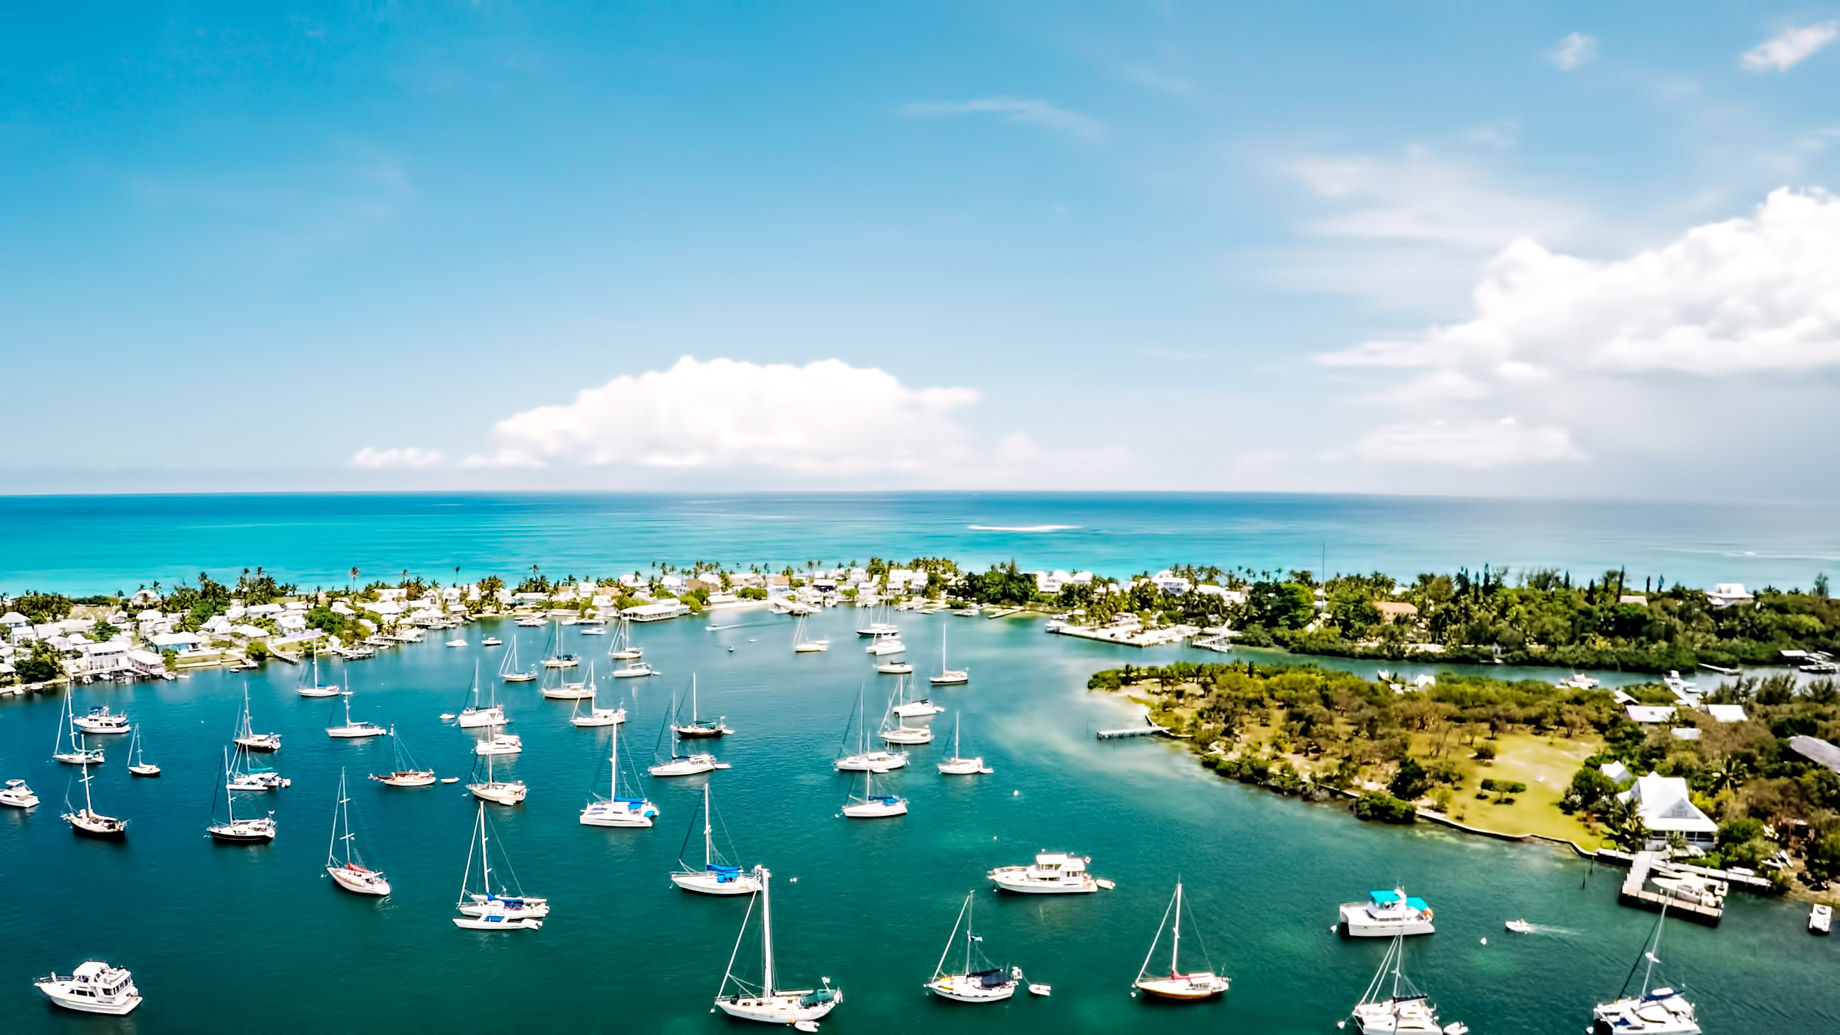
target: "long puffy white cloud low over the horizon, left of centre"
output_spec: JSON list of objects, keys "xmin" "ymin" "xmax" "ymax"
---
[{"xmin": 467, "ymin": 355, "xmax": 979, "ymax": 467}]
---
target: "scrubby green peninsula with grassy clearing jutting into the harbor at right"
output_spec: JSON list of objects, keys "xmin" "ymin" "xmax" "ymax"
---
[{"xmin": 1087, "ymin": 661, "xmax": 1840, "ymax": 886}]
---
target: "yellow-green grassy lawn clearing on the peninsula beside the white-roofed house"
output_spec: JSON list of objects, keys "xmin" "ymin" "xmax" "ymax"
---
[{"xmin": 1450, "ymin": 733, "xmax": 1603, "ymax": 849}]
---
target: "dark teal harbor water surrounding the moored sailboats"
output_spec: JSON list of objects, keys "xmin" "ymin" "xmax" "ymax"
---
[{"xmin": 0, "ymin": 610, "xmax": 1840, "ymax": 1035}]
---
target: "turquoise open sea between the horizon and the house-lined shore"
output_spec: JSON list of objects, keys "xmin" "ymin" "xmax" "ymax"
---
[{"xmin": 0, "ymin": 492, "xmax": 1840, "ymax": 593}]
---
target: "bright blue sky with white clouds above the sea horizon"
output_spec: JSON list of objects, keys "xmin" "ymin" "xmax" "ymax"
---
[{"xmin": 0, "ymin": 2, "xmax": 1840, "ymax": 497}]
